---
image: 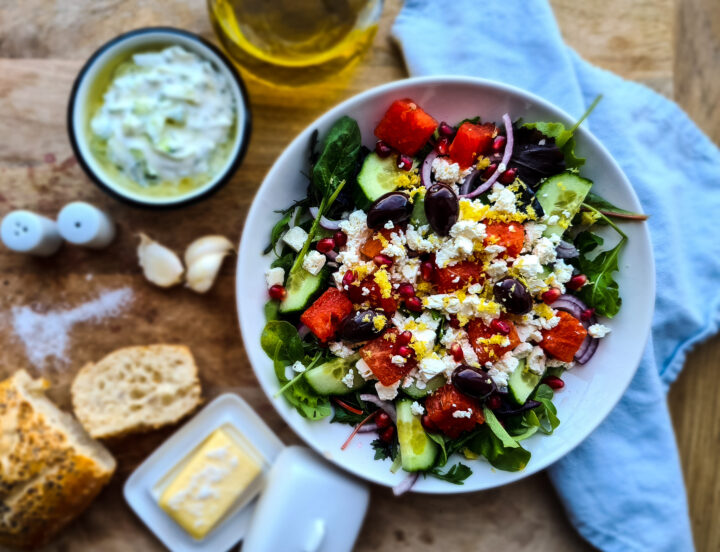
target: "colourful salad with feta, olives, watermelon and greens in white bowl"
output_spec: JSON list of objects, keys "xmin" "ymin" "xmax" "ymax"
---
[{"xmin": 261, "ymin": 98, "xmax": 646, "ymax": 493}]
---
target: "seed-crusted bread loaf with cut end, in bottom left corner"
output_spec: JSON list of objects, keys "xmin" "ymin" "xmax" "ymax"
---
[{"xmin": 0, "ymin": 370, "xmax": 115, "ymax": 548}]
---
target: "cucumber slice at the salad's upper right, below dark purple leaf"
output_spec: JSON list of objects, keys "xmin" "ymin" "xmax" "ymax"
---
[{"xmin": 535, "ymin": 171, "xmax": 592, "ymax": 238}]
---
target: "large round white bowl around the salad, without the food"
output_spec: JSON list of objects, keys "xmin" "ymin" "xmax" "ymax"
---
[{"xmin": 236, "ymin": 76, "xmax": 655, "ymax": 494}]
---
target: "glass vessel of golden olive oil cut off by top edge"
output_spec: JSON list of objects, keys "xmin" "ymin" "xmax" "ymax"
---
[{"xmin": 208, "ymin": 0, "xmax": 382, "ymax": 86}]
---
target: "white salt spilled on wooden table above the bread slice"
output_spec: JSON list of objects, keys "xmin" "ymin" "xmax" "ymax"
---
[{"xmin": 12, "ymin": 287, "xmax": 133, "ymax": 368}]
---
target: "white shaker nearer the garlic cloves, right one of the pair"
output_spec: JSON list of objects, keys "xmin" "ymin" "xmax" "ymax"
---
[{"xmin": 58, "ymin": 201, "xmax": 115, "ymax": 249}]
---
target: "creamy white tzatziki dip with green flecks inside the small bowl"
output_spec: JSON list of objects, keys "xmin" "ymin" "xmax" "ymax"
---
[{"xmin": 90, "ymin": 46, "xmax": 236, "ymax": 196}]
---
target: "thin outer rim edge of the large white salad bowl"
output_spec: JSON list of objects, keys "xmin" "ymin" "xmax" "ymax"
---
[{"xmin": 235, "ymin": 75, "xmax": 656, "ymax": 495}]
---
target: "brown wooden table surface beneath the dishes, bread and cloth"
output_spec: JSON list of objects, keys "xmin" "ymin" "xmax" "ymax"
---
[{"xmin": 0, "ymin": 0, "xmax": 720, "ymax": 552}]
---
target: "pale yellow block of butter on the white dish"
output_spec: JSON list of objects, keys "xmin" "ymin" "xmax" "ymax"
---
[{"xmin": 159, "ymin": 429, "xmax": 261, "ymax": 539}]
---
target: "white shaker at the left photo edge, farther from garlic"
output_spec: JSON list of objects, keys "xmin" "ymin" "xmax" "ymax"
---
[{"xmin": 0, "ymin": 209, "xmax": 62, "ymax": 257}]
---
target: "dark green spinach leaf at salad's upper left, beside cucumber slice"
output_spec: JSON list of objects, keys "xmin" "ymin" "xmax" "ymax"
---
[{"xmin": 312, "ymin": 116, "xmax": 361, "ymax": 197}]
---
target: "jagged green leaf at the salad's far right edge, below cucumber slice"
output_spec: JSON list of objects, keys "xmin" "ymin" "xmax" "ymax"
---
[{"xmin": 577, "ymin": 237, "xmax": 627, "ymax": 318}]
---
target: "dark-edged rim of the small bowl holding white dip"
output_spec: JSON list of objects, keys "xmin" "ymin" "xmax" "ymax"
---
[{"xmin": 66, "ymin": 26, "xmax": 252, "ymax": 210}]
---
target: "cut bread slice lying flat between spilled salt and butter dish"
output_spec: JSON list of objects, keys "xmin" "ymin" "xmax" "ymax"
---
[{"xmin": 71, "ymin": 345, "xmax": 201, "ymax": 439}]
